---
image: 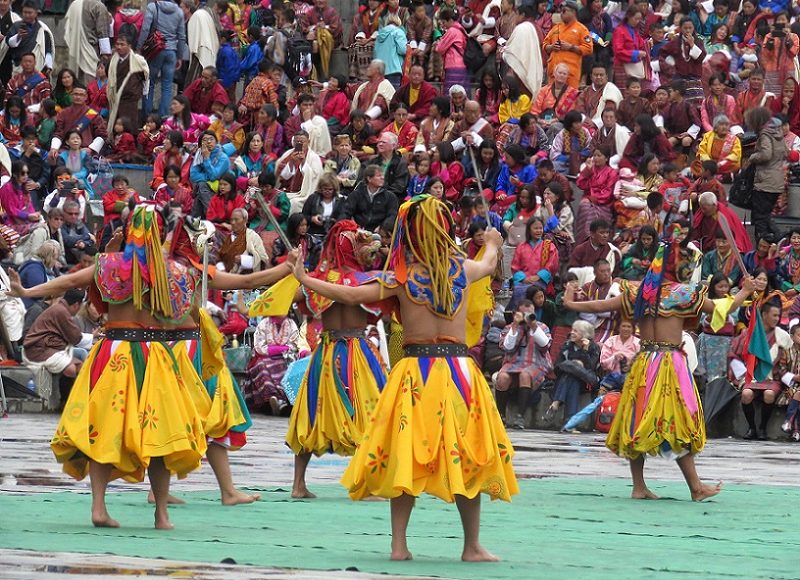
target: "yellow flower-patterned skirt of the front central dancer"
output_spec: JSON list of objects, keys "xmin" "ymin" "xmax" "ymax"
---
[{"xmin": 342, "ymin": 357, "xmax": 519, "ymax": 502}]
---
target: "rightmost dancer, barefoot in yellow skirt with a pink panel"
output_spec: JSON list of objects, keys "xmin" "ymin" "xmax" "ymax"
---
[{"xmin": 564, "ymin": 222, "xmax": 754, "ymax": 501}]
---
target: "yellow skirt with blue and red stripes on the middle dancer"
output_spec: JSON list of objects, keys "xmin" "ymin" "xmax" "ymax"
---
[{"xmin": 286, "ymin": 333, "xmax": 386, "ymax": 456}]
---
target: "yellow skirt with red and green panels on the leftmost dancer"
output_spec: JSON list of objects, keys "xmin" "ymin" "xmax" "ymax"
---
[{"xmin": 50, "ymin": 340, "xmax": 209, "ymax": 482}]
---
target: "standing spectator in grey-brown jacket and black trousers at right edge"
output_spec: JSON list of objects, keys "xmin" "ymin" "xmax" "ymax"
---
[{"xmin": 745, "ymin": 107, "xmax": 787, "ymax": 240}]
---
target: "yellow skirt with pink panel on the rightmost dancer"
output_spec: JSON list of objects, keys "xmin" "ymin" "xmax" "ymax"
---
[{"xmin": 606, "ymin": 350, "xmax": 706, "ymax": 459}]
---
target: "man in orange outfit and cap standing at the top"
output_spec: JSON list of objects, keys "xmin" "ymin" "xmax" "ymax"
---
[{"xmin": 542, "ymin": 0, "xmax": 592, "ymax": 88}]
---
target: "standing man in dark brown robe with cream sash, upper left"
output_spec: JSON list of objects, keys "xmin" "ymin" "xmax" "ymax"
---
[{"xmin": 106, "ymin": 36, "xmax": 151, "ymax": 133}]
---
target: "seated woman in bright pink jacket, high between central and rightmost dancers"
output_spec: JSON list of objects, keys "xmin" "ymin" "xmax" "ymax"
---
[{"xmin": 575, "ymin": 147, "xmax": 619, "ymax": 244}]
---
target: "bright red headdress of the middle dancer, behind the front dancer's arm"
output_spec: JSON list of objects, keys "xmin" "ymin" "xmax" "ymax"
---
[{"xmin": 314, "ymin": 220, "xmax": 381, "ymax": 275}]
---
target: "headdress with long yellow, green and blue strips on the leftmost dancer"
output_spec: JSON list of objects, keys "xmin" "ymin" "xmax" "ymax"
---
[{"xmin": 123, "ymin": 203, "xmax": 173, "ymax": 318}]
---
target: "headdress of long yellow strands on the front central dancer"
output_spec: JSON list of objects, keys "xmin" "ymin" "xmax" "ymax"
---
[{"xmin": 386, "ymin": 195, "xmax": 464, "ymax": 312}]
